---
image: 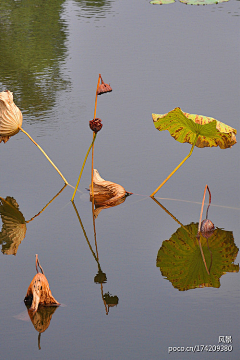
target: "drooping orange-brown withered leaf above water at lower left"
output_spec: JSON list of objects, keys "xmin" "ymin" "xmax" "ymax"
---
[{"xmin": 24, "ymin": 273, "xmax": 60, "ymax": 312}]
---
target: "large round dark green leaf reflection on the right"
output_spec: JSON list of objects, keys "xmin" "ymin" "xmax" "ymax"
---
[{"xmin": 157, "ymin": 223, "xmax": 239, "ymax": 291}]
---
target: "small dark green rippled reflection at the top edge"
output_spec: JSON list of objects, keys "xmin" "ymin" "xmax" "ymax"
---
[{"xmin": 74, "ymin": 0, "xmax": 112, "ymax": 20}]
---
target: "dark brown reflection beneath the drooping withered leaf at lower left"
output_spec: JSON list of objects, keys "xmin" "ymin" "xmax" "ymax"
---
[{"xmin": 28, "ymin": 306, "xmax": 57, "ymax": 333}]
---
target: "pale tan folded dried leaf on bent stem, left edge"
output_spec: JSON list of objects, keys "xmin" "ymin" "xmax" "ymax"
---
[{"xmin": 0, "ymin": 90, "xmax": 22, "ymax": 143}]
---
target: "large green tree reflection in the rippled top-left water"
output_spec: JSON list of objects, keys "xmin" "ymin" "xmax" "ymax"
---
[{"xmin": 0, "ymin": 0, "xmax": 68, "ymax": 116}]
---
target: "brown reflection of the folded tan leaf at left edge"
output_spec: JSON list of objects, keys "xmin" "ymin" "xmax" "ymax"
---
[{"xmin": 0, "ymin": 196, "xmax": 27, "ymax": 255}]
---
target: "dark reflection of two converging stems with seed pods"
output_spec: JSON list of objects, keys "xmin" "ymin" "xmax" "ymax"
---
[{"xmin": 72, "ymin": 201, "xmax": 119, "ymax": 315}]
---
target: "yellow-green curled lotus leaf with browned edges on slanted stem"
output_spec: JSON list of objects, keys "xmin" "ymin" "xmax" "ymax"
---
[{"xmin": 152, "ymin": 107, "xmax": 237, "ymax": 149}]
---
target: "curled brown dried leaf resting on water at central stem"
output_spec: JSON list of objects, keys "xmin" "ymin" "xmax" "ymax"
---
[{"xmin": 89, "ymin": 169, "xmax": 132, "ymax": 218}]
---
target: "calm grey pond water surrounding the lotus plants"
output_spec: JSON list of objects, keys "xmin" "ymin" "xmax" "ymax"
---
[{"xmin": 0, "ymin": 0, "xmax": 240, "ymax": 360}]
